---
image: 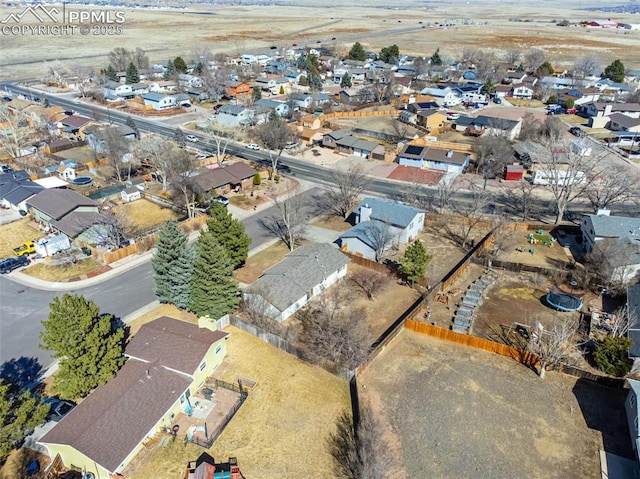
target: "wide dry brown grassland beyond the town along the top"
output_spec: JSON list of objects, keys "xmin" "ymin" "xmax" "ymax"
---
[{"xmin": 0, "ymin": 0, "xmax": 640, "ymax": 78}]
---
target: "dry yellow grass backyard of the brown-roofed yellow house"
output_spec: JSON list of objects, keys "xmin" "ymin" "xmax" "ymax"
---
[{"xmin": 126, "ymin": 326, "xmax": 349, "ymax": 479}]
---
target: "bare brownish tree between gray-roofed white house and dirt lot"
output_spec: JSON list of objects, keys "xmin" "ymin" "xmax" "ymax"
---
[{"xmin": 298, "ymin": 288, "xmax": 368, "ymax": 369}]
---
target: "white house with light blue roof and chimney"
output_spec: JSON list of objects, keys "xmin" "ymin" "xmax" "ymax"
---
[{"xmin": 338, "ymin": 198, "xmax": 424, "ymax": 260}]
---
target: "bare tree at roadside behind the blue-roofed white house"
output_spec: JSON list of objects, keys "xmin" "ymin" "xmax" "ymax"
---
[{"xmin": 321, "ymin": 165, "xmax": 369, "ymax": 218}]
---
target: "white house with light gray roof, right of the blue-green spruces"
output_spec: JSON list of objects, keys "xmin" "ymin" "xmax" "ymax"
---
[{"xmin": 243, "ymin": 243, "xmax": 350, "ymax": 322}]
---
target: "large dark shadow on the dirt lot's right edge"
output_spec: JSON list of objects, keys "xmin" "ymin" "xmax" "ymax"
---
[{"xmin": 572, "ymin": 378, "xmax": 634, "ymax": 459}]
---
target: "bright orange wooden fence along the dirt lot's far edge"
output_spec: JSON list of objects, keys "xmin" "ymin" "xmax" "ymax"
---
[{"xmin": 404, "ymin": 319, "xmax": 538, "ymax": 364}]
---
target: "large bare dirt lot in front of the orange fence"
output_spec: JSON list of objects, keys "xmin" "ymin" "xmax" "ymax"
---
[{"xmin": 358, "ymin": 331, "xmax": 633, "ymax": 479}]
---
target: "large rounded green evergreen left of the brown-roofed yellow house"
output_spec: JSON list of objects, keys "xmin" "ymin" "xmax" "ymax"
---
[{"xmin": 40, "ymin": 294, "xmax": 126, "ymax": 400}]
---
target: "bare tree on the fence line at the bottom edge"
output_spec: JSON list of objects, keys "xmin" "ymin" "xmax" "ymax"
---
[{"xmin": 327, "ymin": 405, "xmax": 396, "ymax": 479}]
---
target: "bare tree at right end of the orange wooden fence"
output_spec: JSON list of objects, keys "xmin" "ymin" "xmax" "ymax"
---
[{"xmin": 528, "ymin": 317, "xmax": 579, "ymax": 379}]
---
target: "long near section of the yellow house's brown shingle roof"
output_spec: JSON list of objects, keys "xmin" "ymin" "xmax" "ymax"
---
[{"xmin": 40, "ymin": 360, "xmax": 191, "ymax": 472}]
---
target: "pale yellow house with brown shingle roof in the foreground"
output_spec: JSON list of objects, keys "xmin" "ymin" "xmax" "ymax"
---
[{"xmin": 39, "ymin": 316, "xmax": 229, "ymax": 479}]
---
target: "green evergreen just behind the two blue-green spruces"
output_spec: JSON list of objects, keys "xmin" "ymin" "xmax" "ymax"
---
[{"xmin": 208, "ymin": 202, "xmax": 251, "ymax": 269}]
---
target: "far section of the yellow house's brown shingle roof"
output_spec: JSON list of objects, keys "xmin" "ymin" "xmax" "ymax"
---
[{"xmin": 125, "ymin": 316, "xmax": 229, "ymax": 374}]
